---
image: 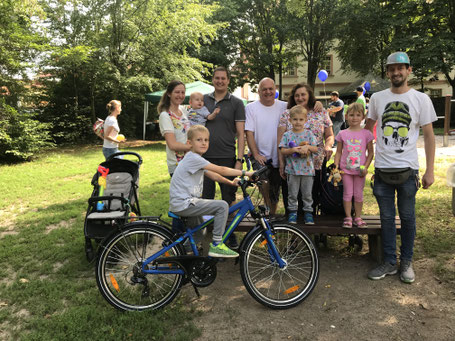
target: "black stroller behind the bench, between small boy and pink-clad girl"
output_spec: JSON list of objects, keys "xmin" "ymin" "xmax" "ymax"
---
[{"xmin": 315, "ymin": 159, "xmax": 363, "ymax": 250}]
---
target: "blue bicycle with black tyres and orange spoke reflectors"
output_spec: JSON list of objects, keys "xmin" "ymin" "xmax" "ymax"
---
[{"xmin": 96, "ymin": 167, "xmax": 319, "ymax": 311}]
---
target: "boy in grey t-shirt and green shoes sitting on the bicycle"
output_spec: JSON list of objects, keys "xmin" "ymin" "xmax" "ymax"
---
[{"xmin": 169, "ymin": 125, "xmax": 253, "ymax": 258}]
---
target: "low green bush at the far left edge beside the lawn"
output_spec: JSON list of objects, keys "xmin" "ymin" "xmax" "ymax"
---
[{"xmin": 0, "ymin": 101, "xmax": 54, "ymax": 162}]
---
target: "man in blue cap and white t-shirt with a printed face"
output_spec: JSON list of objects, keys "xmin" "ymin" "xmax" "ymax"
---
[{"xmin": 365, "ymin": 52, "xmax": 437, "ymax": 283}]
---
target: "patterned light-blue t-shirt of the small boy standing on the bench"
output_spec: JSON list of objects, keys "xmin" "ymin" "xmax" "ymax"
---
[{"xmin": 279, "ymin": 129, "xmax": 317, "ymax": 176}]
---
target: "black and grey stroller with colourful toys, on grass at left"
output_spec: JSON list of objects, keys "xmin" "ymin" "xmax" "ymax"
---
[{"xmin": 84, "ymin": 152, "xmax": 142, "ymax": 262}]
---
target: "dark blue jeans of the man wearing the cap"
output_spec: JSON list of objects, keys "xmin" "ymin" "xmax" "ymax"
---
[{"xmin": 373, "ymin": 170, "xmax": 419, "ymax": 264}]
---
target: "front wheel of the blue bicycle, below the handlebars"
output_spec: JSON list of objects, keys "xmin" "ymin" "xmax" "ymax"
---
[{"xmin": 240, "ymin": 225, "xmax": 319, "ymax": 309}]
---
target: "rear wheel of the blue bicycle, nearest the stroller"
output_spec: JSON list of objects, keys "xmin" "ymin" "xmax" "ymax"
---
[{"xmin": 96, "ymin": 224, "xmax": 184, "ymax": 311}]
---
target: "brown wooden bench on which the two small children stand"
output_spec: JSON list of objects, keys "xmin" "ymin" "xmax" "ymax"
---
[{"xmin": 232, "ymin": 215, "xmax": 401, "ymax": 262}]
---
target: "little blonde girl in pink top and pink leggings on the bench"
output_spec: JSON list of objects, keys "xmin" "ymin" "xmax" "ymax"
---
[{"xmin": 335, "ymin": 103, "xmax": 374, "ymax": 228}]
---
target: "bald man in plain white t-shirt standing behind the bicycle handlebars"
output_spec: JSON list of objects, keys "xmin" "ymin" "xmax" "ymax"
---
[{"xmin": 245, "ymin": 78, "xmax": 287, "ymax": 214}]
